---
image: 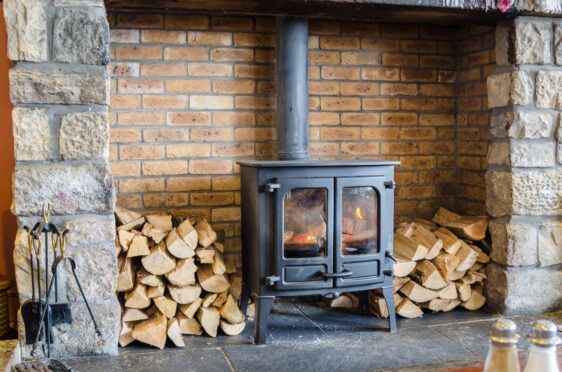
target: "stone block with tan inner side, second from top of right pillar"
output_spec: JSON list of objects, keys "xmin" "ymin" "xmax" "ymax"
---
[{"xmin": 487, "ymin": 71, "xmax": 534, "ymax": 108}]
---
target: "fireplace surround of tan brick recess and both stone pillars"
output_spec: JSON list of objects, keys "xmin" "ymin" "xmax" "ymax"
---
[{"xmin": 4, "ymin": 0, "xmax": 562, "ymax": 355}]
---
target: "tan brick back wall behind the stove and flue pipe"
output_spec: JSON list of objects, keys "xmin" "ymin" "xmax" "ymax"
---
[{"xmin": 110, "ymin": 14, "xmax": 476, "ymax": 262}]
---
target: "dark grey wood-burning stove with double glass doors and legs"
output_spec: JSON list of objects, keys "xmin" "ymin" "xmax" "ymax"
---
[{"xmin": 239, "ymin": 160, "xmax": 397, "ymax": 344}]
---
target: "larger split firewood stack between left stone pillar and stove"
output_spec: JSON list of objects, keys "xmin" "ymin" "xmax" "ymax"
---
[{"xmin": 116, "ymin": 209, "xmax": 245, "ymax": 349}]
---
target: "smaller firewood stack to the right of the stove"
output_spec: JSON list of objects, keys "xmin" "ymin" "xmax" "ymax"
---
[{"xmin": 369, "ymin": 208, "xmax": 490, "ymax": 318}]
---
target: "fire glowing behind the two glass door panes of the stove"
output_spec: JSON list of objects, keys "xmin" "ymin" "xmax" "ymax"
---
[{"xmin": 284, "ymin": 187, "xmax": 379, "ymax": 258}]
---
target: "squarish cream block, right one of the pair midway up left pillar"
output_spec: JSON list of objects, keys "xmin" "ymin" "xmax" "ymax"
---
[{"xmin": 59, "ymin": 112, "xmax": 109, "ymax": 160}]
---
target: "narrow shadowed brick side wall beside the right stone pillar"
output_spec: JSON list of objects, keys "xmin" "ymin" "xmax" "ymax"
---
[{"xmin": 456, "ymin": 26, "xmax": 496, "ymax": 215}]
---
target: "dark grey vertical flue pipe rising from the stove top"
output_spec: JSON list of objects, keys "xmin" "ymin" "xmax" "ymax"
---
[{"xmin": 275, "ymin": 16, "xmax": 308, "ymax": 160}]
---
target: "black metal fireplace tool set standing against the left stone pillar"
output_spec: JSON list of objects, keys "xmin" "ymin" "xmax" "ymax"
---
[{"xmin": 21, "ymin": 203, "xmax": 101, "ymax": 358}]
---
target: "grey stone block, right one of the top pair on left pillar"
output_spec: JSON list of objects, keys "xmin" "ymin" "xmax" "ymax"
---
[{"xmin": 53, "ymin": 8, "xmax": 109, "ymax": 65}]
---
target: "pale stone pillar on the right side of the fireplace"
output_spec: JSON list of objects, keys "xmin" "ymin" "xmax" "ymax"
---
[{"xmin": 486, "ymin": 17, "xmax": 562, "ymax": 313}]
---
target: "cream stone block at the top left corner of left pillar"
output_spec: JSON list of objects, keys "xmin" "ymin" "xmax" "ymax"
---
[{"xmin": 4, "ymin": 0, "xmax": 49, "ymax": 62}]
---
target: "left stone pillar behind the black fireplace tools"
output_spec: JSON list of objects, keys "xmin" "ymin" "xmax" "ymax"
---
[{"xmin": 4, "ymin": 0, "xmax": 120, "ymax": 356}]
